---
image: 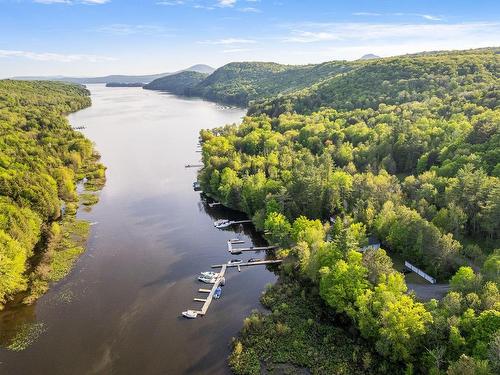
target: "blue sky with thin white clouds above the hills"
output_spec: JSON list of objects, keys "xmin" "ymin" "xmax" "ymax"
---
[{"xmin": 0, "ymin": 0, "xmax": 500, "ymax": 77}]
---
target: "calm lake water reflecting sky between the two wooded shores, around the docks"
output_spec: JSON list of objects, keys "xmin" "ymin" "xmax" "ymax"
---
[{"xmin": 0, "ymin": 85, "xmax": 276, "ymax": 375}]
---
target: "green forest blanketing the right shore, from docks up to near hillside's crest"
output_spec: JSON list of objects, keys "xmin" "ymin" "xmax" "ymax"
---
[{"xmin": 199, "ymin": 49, "xmax": 500, "ymax": 374}]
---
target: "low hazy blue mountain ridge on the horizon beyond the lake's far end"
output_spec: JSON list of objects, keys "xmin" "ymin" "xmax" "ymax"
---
[{"xmin": 13, "ymin": 64, "xmax": 214, "ymax": 84}]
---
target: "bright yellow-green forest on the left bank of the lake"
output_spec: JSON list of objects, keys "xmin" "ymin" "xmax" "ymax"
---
[{"xmin": 0, "ymin": 80, "xmax": 104, "ymax": 309}]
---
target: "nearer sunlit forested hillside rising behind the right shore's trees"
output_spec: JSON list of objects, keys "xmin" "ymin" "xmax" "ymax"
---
[{"xmin": 249, "ymin": 49, "xmax": 500, "ymax": 116}]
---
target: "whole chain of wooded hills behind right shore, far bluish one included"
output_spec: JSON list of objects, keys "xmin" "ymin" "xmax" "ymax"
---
[{"xmin": 146, "ymin": 49, "xmax": 498, "ymax": 111}]
